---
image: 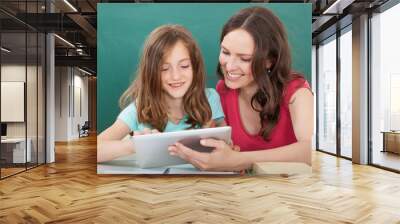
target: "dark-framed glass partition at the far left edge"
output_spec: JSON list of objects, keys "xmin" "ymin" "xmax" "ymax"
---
[{"xmin": 0, "ymin": 1, "xmax": 46, "ymax": 179}]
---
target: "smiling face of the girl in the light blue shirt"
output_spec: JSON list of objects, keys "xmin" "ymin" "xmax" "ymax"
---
[{"xmin": 161, "ymin": 41, "xmax": 193, "ymax": 99}]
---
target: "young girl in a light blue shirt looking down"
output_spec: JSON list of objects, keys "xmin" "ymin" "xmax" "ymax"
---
[{"xmin": 97, "ymin": 25, "xmax": 225, "ymax": 162}]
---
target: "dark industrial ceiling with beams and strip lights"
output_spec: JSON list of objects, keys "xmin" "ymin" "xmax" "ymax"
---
[{"xmin": 0, "ymin": 0, "xmax": 394, "ymax": 76}]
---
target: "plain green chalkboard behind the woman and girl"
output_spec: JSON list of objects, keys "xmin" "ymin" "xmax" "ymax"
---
[{"xmin": 97, "ymin": 3, "xmax": 312, "ymax": 133}]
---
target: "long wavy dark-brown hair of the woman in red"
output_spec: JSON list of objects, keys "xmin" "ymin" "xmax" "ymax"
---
[{"xmin": 217, "ymin": 7, "xmax": 301, "ymax": 140}]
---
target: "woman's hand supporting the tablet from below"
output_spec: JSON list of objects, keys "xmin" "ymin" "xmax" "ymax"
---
[{"xmin": 168, "ymin": 138, "xmax": 251, "ymax": 171}]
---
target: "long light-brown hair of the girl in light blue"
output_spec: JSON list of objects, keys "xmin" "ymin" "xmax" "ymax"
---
[{"xmin": 119, "ymin": 25, "xmax": 211, "ymax": 131}]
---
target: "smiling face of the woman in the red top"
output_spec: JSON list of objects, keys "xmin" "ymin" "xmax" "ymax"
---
[{"xmin": 219, "ymin": 29, "xmax": 255, "ymax": 89}]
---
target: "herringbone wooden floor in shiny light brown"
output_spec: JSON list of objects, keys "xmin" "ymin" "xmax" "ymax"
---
[{"xmin": 0, "ymin": 137, "xmax": 400, "ymax": 224}]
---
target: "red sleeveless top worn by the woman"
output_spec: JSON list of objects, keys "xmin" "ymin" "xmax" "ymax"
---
[{"xmin": 216, "ymin": 78, "xmax": 311, "ymax": 151}]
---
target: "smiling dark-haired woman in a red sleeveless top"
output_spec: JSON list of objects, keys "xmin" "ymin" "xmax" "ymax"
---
[{"xmin": 169, "ymin": 7, "xmax": 313, "ymax": 171}]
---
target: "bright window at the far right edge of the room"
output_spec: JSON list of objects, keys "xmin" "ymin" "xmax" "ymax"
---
[{"xmin": 370, "ymin": 1, "xmax": 400, "ymax": 170}]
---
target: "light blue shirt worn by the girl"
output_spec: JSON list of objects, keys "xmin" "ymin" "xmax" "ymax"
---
[{"xmin": 118, "ymin": 88, "xmax": 225, "ymax": 132}]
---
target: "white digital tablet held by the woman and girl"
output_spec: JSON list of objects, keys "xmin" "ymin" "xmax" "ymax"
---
[{"xmin": 132, "ymin": 126, "xmax": 231, "ymax": 168}]
